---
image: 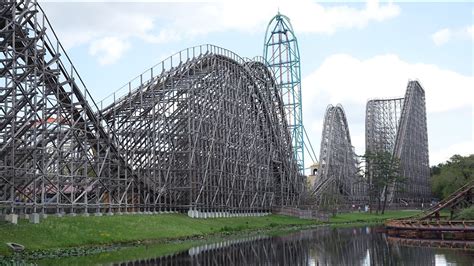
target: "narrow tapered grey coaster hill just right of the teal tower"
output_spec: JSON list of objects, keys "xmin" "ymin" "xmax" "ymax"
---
[{"xmin": 312, "ymin": 105, "xmax": 365, "ymax": 207}]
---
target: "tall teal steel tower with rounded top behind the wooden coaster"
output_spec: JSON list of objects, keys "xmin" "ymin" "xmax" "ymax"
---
[{"xmin": 263, "ymin": 12, "xmax": 304, "ymax": 174}]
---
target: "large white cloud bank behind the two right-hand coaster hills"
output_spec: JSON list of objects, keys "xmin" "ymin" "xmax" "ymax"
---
[{"xmin": 302, "ymin": 54, "xmax": 474, "ymax": 164}]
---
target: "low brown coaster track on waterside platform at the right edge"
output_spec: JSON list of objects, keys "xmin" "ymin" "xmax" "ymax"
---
[{"xmin": 385, "ymin": 181, "xmax": 474, "ymax": 249}]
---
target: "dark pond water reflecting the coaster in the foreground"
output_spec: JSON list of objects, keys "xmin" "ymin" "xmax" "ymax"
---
[{"xmin": 40, "ymin": 227, "xmax": 474, "ymax": 265}]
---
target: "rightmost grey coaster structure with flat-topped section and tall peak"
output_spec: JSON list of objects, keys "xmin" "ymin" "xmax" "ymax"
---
[{"xmin": 366, "ymin": 81, "xmax": 431, "ymax": 202}]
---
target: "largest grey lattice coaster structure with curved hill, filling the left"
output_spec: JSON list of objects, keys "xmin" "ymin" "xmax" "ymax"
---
[{"xmin": 0, "ymin": 1, "xmax": 304, "ymax": 217}]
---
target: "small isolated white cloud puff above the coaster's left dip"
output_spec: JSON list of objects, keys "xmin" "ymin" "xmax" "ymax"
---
[{"xmin": 89, "ymin": 37, "xmax": 130, "ymax": 65}]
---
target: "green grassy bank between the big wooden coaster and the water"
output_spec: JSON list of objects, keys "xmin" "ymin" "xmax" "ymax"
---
[{"xmin": 0, "ymin": 211, "xmax": 416, "ymax": 256}]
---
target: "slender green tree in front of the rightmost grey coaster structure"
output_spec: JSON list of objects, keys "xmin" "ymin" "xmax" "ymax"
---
[{"xmin": 364, "ymin": 151, "xmax": 406, "ymax": 214}]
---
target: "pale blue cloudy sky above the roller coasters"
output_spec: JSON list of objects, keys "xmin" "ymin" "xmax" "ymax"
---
[{"xmin": 39, "ymin": 0, "xmax": 474, "ymax": 166}]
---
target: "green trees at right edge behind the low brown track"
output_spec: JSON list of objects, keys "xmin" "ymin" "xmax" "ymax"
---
[{"xmin": 430, "ymin": 154, "xmax": 474, "ymax": 200}]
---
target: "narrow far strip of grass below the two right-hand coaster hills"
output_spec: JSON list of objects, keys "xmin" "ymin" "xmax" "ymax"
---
[{"xmin": 329, "ymin": 210, "xmax": 420, "ymax": 224}]
